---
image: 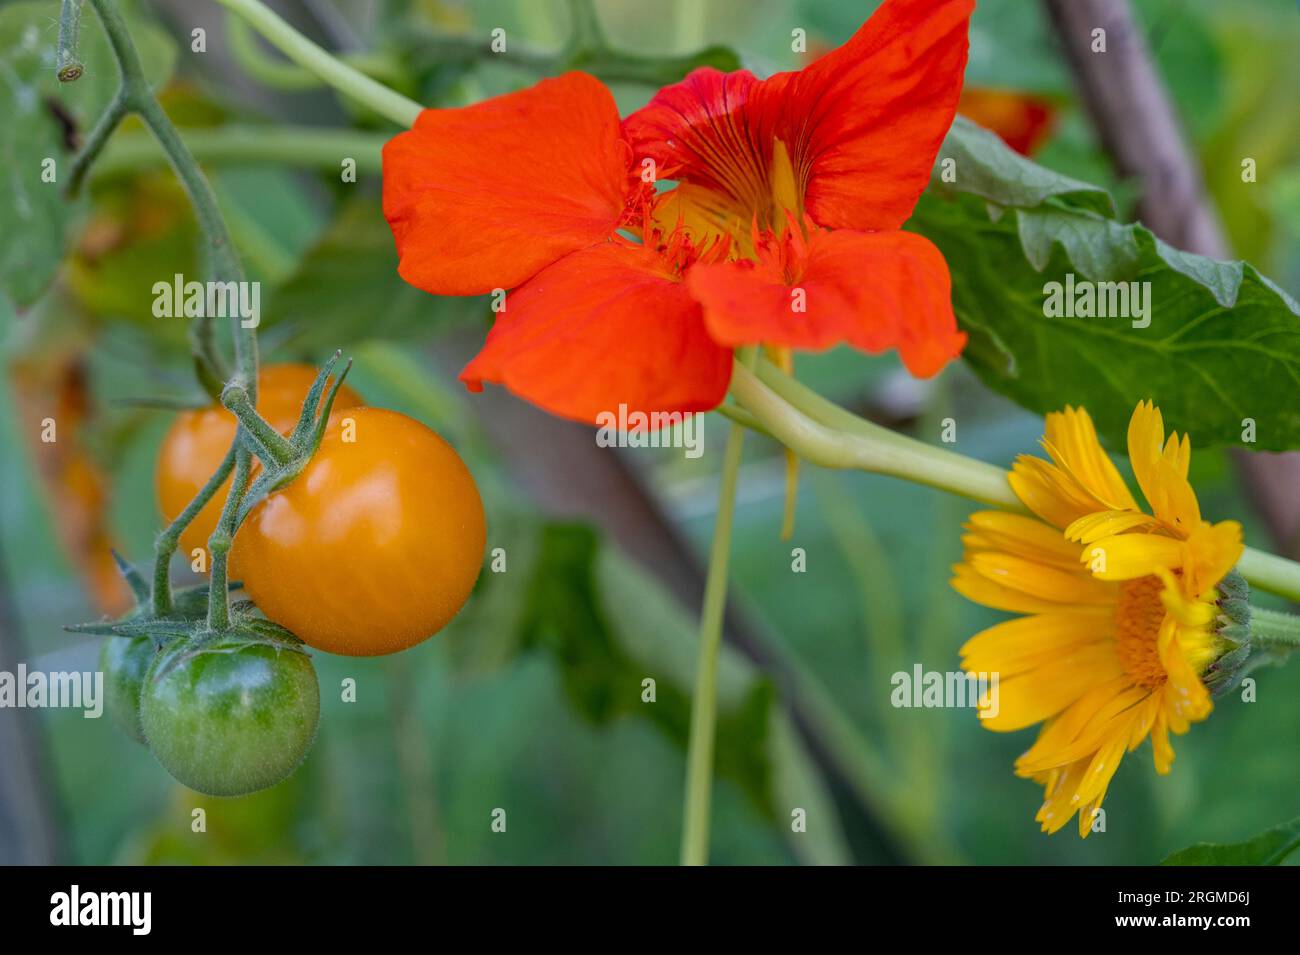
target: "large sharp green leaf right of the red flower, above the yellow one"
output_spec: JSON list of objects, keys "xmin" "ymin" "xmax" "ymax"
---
[{"xmin": 909, "ymin": 121, "xmax": 1300, "ymax": 451}]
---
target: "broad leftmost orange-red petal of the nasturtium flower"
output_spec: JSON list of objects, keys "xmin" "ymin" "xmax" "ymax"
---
[{"xmin": 384, "ymin": 73, "xmax": 640, "ymax": 295}]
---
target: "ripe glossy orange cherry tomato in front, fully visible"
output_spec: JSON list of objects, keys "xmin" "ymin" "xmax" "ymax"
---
[{"xmin": 231, "ymin": 408, "xmax": 486, "ymax": 656}]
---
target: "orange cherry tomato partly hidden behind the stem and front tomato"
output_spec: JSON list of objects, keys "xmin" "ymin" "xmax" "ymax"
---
[{"xmin": 153, "ymin": 364, "xmax": 361, "ymax": 561}]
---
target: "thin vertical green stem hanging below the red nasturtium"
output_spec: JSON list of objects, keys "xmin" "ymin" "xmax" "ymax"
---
[{"xmin": 681, "ymin": 348, "xmax": 755, "ymax": 865}]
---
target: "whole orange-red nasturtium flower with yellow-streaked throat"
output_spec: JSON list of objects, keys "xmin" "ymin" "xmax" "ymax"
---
[{"xmin": 384, "ymin": 0, "xmax": 974, "ymax": 421}]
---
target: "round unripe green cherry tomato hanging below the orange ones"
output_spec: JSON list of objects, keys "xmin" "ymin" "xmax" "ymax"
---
[{"xmin": 140, "ymin": 641, "xmax": 320, "ymax": 796}]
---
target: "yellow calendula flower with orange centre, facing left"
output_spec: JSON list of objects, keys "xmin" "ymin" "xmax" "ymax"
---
[{"xmin": 953, "ymin": 403, "xmax": 1243, "ymax": 837}]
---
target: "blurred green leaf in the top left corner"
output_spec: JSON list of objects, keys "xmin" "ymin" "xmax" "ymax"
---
[{"xmin": 0, "ymin": 0, "xmax": 176, "ymax": 307}]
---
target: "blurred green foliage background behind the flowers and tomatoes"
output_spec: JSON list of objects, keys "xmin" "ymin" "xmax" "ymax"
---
[{"xmin": 0, "ymin": 0, "xmax": 1300, "ymax": 864}]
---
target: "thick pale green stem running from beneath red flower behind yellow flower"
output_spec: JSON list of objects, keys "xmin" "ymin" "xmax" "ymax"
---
[{"xmin": 731, "ymin": 360, "xmax": 1300, "ymax": 602}]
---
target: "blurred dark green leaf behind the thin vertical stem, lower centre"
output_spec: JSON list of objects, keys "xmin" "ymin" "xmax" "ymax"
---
[{"xmin": 521, "ymin": 524, "xmax": 849, "ymax": 864}]
